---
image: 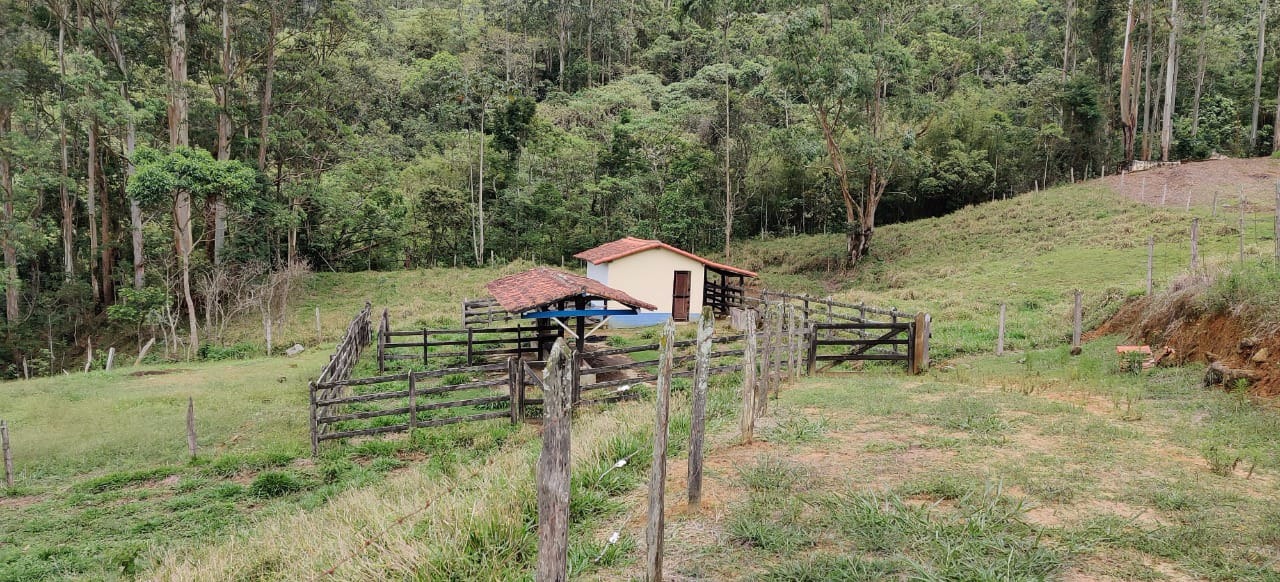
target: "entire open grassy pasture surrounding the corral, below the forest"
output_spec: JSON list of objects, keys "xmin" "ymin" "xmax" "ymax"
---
[{"xmin": 0, "ymin": 166, "xmax": 1280, "ymax": 581}]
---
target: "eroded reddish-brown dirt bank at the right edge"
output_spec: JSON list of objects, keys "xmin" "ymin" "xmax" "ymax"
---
[{"xmin": 1089, "ymin": 298, "xmax": 1280, "ymax": 397}]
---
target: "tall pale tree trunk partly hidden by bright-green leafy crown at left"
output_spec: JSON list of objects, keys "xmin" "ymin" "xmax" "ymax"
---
[{"xmin": 169, "ymin": 0, "xmax": 200, "ymax": 356}]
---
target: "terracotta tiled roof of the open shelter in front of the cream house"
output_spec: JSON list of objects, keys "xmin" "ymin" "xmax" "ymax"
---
[{"xmin": 485, "ymin": 267, "xmax": 658, "ymax": 313}]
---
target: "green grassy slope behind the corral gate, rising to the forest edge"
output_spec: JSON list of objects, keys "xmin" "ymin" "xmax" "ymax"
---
[{"xmin": 733, "ymin": 183, "xmax": 1280, "ymax": 359}]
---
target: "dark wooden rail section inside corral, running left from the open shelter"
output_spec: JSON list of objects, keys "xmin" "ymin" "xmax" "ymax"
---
[{"xmin": 378, "ymin": 310, "xmax": 559, "ymax": 374}]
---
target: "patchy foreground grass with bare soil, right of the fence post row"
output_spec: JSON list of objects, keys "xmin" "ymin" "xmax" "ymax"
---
[{"xmin": 594, "ymin": 338, "xmax": 1280, "ymax": 581}]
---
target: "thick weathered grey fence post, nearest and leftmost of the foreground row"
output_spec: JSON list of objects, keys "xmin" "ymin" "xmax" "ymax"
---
[{"xmin": 536, "ymin": 339, "xmax": 572, "ymax": 582}]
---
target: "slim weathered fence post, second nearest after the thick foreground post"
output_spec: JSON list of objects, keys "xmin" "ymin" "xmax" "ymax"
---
[{"xmin": 644, "ymin": 319, "xmax": 676, "ymax": 582}]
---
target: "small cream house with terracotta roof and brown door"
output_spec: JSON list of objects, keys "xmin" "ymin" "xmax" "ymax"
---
[{"xmin": 573, "ymin": 237, "xmax": 756, "ymax": 326}]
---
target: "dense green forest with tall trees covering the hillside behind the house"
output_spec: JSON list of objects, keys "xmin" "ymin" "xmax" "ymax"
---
[{"xmin": 0, "ymin": 0, "xmax": 1280, "ymax": 370}]
